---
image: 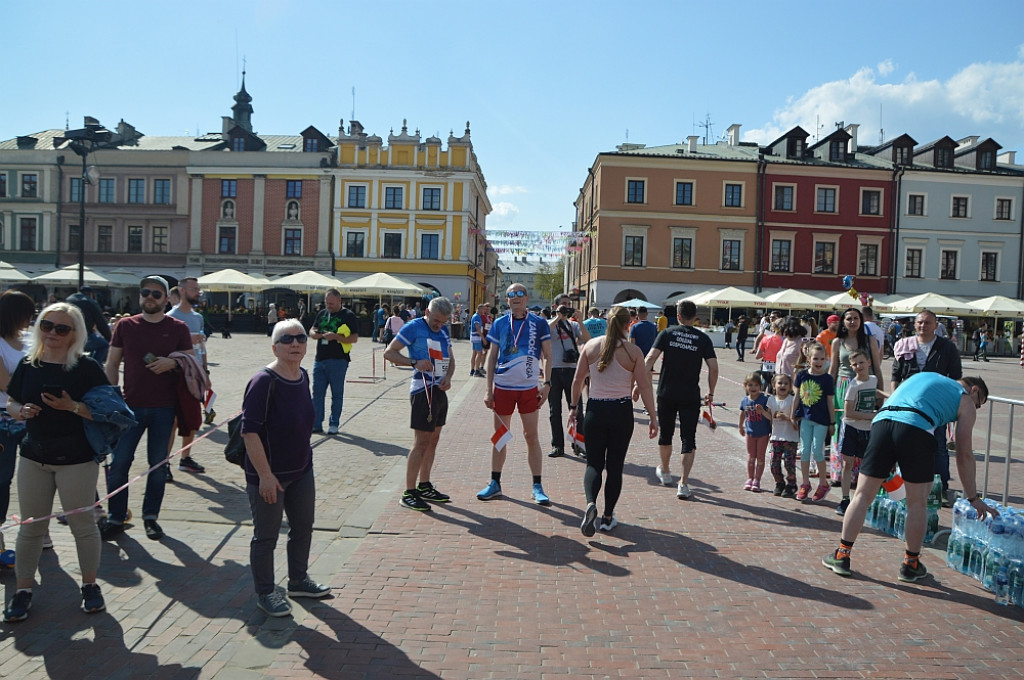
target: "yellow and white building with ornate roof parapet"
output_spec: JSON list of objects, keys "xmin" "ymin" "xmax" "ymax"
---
[{"xmin": 333, "ymin": 121, "xmax": 490, "ymax": 307}]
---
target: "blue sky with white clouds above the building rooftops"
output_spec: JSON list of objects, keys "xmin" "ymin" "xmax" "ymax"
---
[{"xmin": 6, "ymin": 0, "xmax": 1024, "ymax": 230}]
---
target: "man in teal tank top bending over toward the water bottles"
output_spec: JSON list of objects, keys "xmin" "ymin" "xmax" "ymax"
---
[{"xmin": 821, "ymin": 373, "xmax": 994, "ymax": 583}]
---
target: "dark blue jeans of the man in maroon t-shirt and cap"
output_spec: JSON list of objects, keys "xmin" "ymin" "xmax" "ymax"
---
[{"xmin": 106, "ymin": 407, "xmax": 174, "ymax": 524}]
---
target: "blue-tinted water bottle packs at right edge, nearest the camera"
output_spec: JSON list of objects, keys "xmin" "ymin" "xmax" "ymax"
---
[{"xmin": 946, "ymin": 499, "xmax": 1024, "ymax": 607}]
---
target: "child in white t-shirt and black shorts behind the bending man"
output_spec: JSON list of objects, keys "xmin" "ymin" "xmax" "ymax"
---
[{"xmin": 836, "ymin": 349, "xmax": 886, "ymax": 515}]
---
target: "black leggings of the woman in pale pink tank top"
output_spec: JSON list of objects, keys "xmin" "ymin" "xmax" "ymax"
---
[{"xmin": 583, "ymin": 397, "xmax": 633, "ymax": 517}]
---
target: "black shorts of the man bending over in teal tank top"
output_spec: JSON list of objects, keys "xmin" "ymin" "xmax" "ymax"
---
[{"xmin": 856, "ymin": 420, "xmax": 938, "ymax": 483}]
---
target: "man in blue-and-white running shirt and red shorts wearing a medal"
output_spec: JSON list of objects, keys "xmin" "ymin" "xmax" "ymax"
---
[{"xmin": 476, "ymin": 284, "xmax": 551, "ymax": 505}]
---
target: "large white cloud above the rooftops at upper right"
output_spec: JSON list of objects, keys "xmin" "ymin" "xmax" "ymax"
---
[{"xmin": 743, "ymin": 58, "xmax": 1024, "ymax": 147}]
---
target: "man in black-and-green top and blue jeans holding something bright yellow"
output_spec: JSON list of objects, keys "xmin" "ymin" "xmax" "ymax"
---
[{"xmin": 309, "ymin": 288, "xmax": 359, "ymax": 434}]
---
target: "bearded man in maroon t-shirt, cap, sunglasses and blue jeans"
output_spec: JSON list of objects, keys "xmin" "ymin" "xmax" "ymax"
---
[{"xmin": 99, "ymin": 277, "xmax": 194, "ymax": 541}]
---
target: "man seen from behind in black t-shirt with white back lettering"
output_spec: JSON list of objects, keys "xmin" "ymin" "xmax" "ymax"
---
[{"xmin": 634, "ymin": 301, "xmax": 718, "ymax": 499}]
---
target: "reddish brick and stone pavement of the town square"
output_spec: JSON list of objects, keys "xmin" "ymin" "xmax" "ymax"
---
[{"xmin": 0, "ymin": 335, "xmax": 1024, "ymax": 680}]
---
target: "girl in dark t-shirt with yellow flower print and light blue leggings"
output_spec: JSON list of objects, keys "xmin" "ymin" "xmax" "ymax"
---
[{"xmin": 791, "ymin": 342, "xmax": 836, "ymax": 502}]
